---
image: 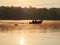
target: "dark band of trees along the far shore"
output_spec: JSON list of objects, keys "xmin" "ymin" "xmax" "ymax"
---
[{"xmin": 0, "ymin": 6, "xmax": 60, "ymax": 20}]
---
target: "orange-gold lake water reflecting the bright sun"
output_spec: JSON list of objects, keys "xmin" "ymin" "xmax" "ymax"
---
[{"xmin": 0, "ymin": 20, "xmax": 60, "ymax": 45}]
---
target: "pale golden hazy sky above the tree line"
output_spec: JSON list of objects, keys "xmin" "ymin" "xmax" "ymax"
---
[{"xmin": 0, "ymin": 0, "xmax": 60, "ymax": 8}]
